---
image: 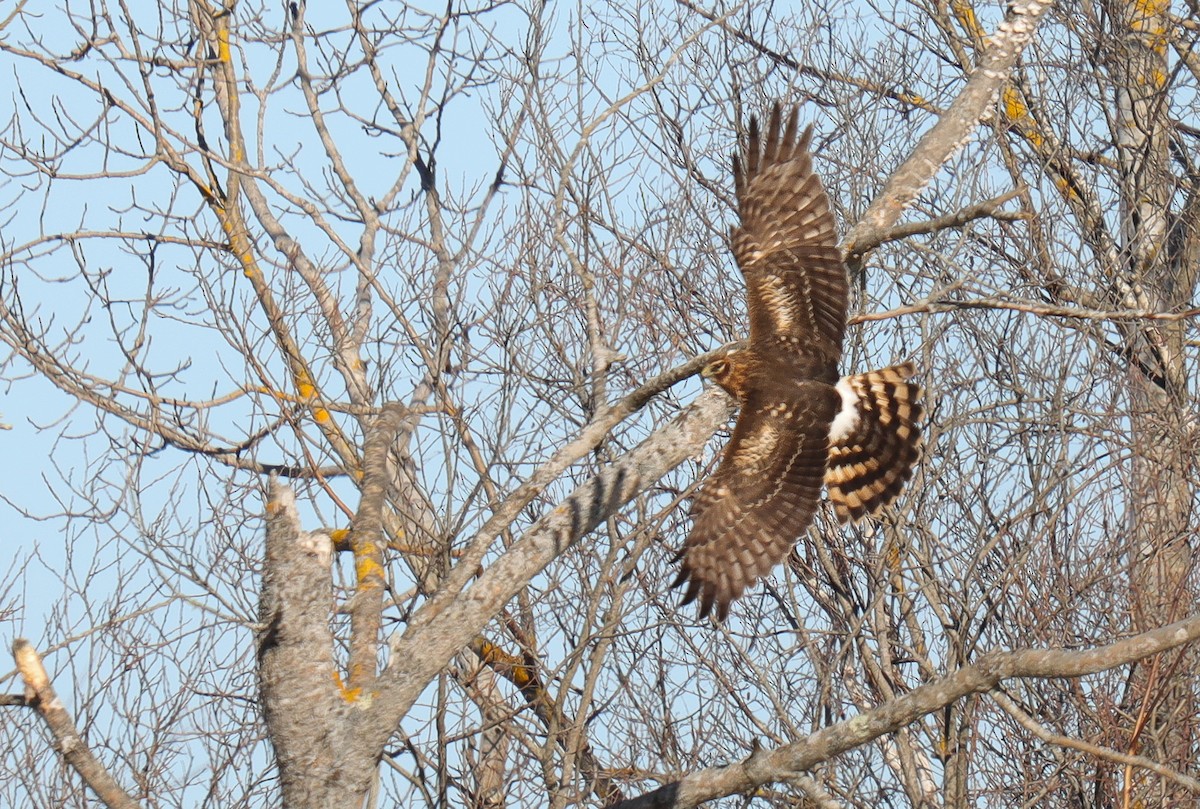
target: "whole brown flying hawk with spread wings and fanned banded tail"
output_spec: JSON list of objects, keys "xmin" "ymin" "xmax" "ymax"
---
[{"xmin": 676, "ymin": 103, "xmax": 922, "ymax": 621}]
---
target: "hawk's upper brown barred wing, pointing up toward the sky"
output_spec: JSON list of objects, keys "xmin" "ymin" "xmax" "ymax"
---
[{"xmin": 732, "ymin": 103, "xmax": 850, "ymax": 365}]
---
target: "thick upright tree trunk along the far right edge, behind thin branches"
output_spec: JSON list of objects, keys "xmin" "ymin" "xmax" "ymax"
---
[{"xmin": 1110, "ymin": 0, "xmax": 1196, "ymax": 805}]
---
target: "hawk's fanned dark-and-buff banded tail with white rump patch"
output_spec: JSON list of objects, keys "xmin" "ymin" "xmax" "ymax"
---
[{"xmin": 824, "ymin": 362, "xmax": 924, "ymax": 522}]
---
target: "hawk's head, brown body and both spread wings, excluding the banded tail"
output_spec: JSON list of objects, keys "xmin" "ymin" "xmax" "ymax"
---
[{"xmin": 676, "ymin": 104, "xmax": 850, "ymax": 619}]
